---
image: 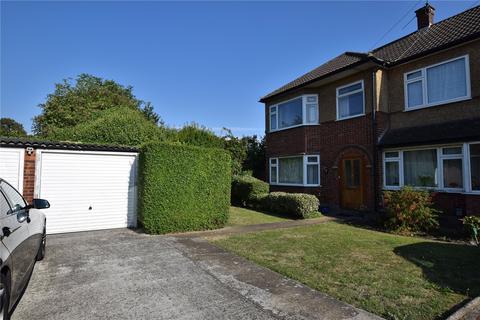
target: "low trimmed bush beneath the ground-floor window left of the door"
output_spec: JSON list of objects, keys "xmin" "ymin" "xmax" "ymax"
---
[{"xmin": 257, "ymin": 192, "xmax": 320, "ymax": 219}]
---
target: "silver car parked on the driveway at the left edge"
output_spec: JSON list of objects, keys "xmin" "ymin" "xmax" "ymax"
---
[{"xmin": 0, "ymin": 178, "xmax": 50, "ymax": 320}]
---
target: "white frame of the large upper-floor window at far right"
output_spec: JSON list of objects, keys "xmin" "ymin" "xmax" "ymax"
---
[{"xmin": 403, "ymin": 54, "xmax": 471, "ymax": 111}]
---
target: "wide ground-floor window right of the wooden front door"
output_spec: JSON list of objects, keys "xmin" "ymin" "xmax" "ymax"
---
[{"xmin": 383, "ymin": 143, "xmax": 480, "ymax": 192}]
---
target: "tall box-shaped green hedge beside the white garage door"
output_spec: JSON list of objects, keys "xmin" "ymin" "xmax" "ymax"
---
[{"xmin": 139, "ymin": 142, "xmax": 231, "ymax": 234}]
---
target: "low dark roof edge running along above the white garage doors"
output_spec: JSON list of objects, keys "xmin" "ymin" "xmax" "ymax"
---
[{"xmin": 0, "ymin": 137, "xmax": 138, "ymax": 152}]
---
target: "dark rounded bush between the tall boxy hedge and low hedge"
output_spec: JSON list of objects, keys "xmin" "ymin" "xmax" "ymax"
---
[{"xmin": 232, "ymin": 175, "xmax": 269, "ymax": 207}]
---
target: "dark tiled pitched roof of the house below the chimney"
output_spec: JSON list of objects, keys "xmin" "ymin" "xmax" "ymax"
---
[{"xmin": 260, "ymin": 6, "xmax": 480, "ymax": 102}]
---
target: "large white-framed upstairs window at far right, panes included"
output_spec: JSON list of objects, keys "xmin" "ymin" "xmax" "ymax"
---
[{"xmin": 405, "ymin": 56, "xmax": 470, "ymax": 110}]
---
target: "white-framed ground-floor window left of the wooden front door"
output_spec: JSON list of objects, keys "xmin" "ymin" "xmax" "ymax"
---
[{"xmin": 269, "ymin": 155, "xmax": 320, "ymax": 186}]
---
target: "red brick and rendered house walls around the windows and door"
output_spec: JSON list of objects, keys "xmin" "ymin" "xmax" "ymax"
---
[{"xmin": 265, "ymin": 41, "xmax": 480, "ymax": 218}]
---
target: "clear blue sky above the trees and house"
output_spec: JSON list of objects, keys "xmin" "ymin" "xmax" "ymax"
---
[{"xmin": 0, "ymin": 1, "xmax": 478, "ymax": 135}]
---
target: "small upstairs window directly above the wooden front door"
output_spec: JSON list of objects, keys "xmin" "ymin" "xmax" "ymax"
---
[{"xmin": 337, "ymin": 81, "xmax": 365, "ymax": 120}]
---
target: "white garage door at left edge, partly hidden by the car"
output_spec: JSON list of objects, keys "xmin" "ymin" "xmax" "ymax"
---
[{"xmin": 0, "ymin": 148, "xmax": 25, "ymax": 193}]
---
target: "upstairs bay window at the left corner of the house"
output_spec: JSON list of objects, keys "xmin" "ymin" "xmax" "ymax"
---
[{"xmin": 269, "ymin": 95, "xmax": 318, "ymax": 131}]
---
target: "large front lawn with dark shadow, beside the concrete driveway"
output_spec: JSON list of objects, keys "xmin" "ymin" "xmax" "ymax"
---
[{"xmin": 212, "ymin": 222, "xmax": 480, "ymax": 319}]
